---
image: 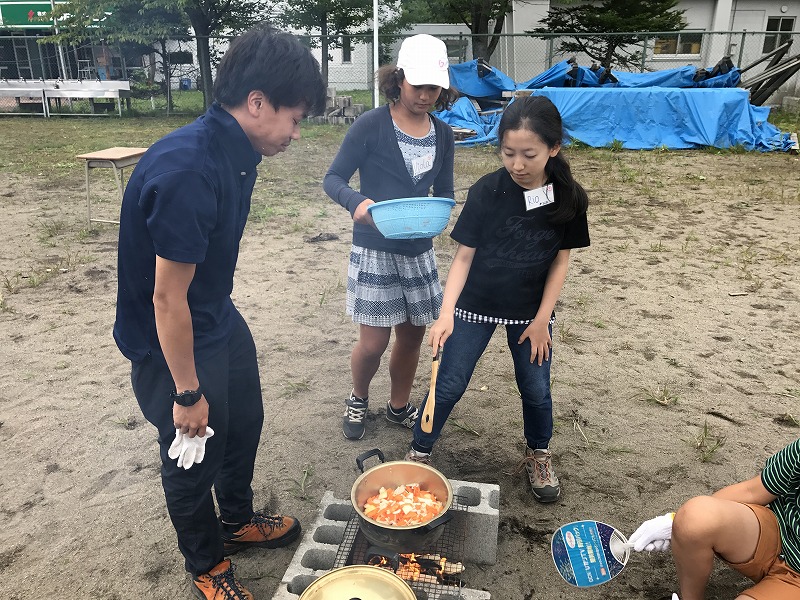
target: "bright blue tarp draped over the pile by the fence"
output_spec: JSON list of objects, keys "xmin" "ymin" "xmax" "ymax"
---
[{"xmin": 437, "ymin": 61, "xmax": 792, "ymax": 152}]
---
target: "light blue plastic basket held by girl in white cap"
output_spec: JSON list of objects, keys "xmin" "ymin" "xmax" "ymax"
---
[{"xmin": 367, "ymin": 197, "xmax": 456, "ymax": 240}]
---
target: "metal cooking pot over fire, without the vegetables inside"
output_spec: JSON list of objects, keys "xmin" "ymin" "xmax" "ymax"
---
[{"xmin": 350, "ymin": 448, "xmax": 453, "ymax": 553}]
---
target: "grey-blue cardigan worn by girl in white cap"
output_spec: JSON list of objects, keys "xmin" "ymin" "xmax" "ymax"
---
[{"xmin": 322, "ymin": 104, "xmax": 455, "ymax": 256}]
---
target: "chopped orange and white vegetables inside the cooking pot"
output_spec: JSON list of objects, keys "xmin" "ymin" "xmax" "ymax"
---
[{"xmin": 364, "ymin": 483, "xmax": 444, "ymax": 526}]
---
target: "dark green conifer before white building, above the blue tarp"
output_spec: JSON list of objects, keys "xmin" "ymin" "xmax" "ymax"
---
[{"xmin": 527, "ymin": 0, "xmax": 686, "ymax": 70}]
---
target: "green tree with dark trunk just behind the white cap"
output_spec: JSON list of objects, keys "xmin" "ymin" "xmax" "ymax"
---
[{"xmin": 403, "ymin": 0, "xmax": 513, "ymax": 60}]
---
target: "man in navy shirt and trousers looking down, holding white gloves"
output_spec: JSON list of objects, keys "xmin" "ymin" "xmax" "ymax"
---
[{"xmin": 114, "ymin": 27, "xmax": 325, "ymax": 599}]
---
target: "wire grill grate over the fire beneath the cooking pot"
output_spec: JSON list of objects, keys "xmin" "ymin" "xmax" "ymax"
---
[{"xmin": 333, "ymin": 495, "xmax": 468, "ymax": 600}]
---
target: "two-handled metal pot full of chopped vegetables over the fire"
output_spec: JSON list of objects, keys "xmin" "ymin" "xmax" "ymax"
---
[{"xmin": 350, "ymin": 448, "xmax": 453, "ymax": 553}]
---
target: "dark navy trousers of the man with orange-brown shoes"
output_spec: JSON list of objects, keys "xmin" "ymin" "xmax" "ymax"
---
[{"xmin": 131, "ymin": 312, "xmax": 264, "ymax": 575}]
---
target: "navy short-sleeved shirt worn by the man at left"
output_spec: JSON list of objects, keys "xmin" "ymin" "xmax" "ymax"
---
[{"xmin": 114, "ymin": 104, "xmax": 261, "ymax": 361}]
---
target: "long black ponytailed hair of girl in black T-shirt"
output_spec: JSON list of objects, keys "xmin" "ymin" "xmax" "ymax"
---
[{"xmin": 497, "ymin": 96, "xmax": 589, "ymax": 224}]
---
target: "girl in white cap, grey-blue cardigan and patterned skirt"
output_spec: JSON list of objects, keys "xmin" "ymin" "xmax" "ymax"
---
[{"xmin": 323, "ymin": 34, "xmax": 458, "ymax": 440}]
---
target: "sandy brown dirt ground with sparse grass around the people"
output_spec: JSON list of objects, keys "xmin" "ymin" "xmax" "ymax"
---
[{"xmin": 0, "ymin": 120, "xmax": 800, "ymax": 600}]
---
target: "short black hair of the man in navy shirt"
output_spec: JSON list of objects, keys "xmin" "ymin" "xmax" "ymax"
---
[{"xmin": 214, "ymin": 25, "xmax": 325, "ymax": 115}]
